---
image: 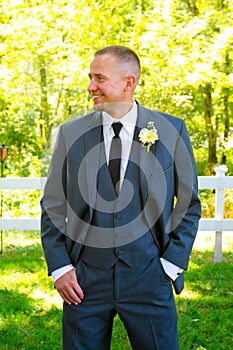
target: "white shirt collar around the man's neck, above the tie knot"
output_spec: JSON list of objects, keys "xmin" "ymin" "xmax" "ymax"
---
[{"xmin": 102, "ymin": 101, "xmax": 137, "ymax": 134}]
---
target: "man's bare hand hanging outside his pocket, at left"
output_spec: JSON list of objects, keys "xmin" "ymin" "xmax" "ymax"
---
[{"xmin": 54, "ymin": 268, "xmax": 84, "ymax": 305}]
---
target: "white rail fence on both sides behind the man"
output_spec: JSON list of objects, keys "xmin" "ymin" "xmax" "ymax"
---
[{"xmin": 0, "ymin": 165, "xmax": 233, "ymax": 262}]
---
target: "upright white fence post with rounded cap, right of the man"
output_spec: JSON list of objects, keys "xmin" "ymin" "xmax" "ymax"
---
[{"xmin": 214, "ymin": 164, "xmax": 228, "ymax": 262}]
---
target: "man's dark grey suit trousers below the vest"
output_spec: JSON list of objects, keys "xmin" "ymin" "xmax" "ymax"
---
[{"xmin": 63, "ymin": 252, "xmax": 179, "ymax": 350}]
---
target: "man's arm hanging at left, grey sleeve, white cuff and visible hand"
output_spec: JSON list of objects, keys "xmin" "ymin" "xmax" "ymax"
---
[{"xmin": 41, "ymin": 128, "xmax": 83, "ymax": 304}]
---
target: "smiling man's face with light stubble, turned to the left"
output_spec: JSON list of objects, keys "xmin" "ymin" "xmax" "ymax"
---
[{"xmin": 88, "ymin": 55, "xmax": 128, "ymax": 112}]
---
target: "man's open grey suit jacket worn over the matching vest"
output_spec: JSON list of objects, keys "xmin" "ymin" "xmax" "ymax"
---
[{"xmin": 41, "ymin": 105, "xmax": 201, "ymax": 293}]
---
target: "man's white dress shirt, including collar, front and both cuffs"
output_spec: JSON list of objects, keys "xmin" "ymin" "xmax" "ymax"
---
[{"xmin": 52, "ymin": 101, "xmax": 183, "ymax": 282}]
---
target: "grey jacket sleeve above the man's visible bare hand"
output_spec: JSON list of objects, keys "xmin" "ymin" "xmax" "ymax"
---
[{"xmin": 41, "ymin": 126, "xmax": 71, "ymax": 275}]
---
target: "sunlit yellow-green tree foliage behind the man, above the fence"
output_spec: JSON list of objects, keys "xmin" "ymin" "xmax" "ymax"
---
[{"xmin": 0, "ymin": 0, "xmax": 233, "ymax": 176}]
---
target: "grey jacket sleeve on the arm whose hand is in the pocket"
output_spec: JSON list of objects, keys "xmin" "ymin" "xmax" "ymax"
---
[{"xmin": 162, "ymin": 122, "xmax": 201, "ymax": 269}]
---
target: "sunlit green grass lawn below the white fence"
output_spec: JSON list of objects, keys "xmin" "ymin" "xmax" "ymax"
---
[{"xmin": 0, "ymin": 232, "xmax": 233, "ymax": 350}]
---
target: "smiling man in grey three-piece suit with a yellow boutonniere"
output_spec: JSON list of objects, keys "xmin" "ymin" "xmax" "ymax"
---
[{"xmin": 41, "ymin": 46, "xmax": 200, "ymax": 350}]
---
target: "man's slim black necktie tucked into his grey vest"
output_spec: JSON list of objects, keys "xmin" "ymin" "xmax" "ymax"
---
[{"xmin": 108, "ymin": 123, "xmax": 122, "ymax": 193}]
